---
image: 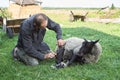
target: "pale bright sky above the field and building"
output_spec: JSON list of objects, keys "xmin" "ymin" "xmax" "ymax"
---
[{"xmin": 0, "ymin": 0, "xmax": 120, "ymax": 8}]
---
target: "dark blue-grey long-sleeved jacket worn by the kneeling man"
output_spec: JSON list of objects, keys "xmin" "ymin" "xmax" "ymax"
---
[{"xmin": 17, "ymin": 15, "xmax": 62, "ymax": 60}]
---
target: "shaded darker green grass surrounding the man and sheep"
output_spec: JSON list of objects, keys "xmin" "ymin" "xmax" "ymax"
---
[{"xmin": 0, "ymin": 27, "xmax": 120, "ymax": 80}]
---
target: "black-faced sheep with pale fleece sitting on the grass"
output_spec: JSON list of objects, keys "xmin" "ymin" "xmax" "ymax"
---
[{"xmin": 55, "ymin": 37, "xmax": 102, "ymax": 68}]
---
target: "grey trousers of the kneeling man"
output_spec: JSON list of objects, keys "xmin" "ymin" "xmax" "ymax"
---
[{"xmin": 12, "ymin": 42, "xmax": 51, "ymax": 66}]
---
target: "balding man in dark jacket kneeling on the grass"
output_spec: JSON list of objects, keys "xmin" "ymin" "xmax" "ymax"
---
[{"xmin": 12, "ymin": 13, "xmax": 64, "ymax": 65}]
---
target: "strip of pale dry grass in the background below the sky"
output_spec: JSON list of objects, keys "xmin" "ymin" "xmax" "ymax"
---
[{"xmin": 43, "ymin": 8, "xmax": 120, "ymax": 19}]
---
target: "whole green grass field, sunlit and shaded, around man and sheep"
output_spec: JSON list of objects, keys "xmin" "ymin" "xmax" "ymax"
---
[{"xmin": 0, "ymin": 10, "xmax": 120, "ymax": 80}]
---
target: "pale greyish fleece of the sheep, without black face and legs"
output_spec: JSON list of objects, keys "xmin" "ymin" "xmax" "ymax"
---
[{"xmin": 56, "ymin": 37, "xmax": 102, "ymax": 63}]
